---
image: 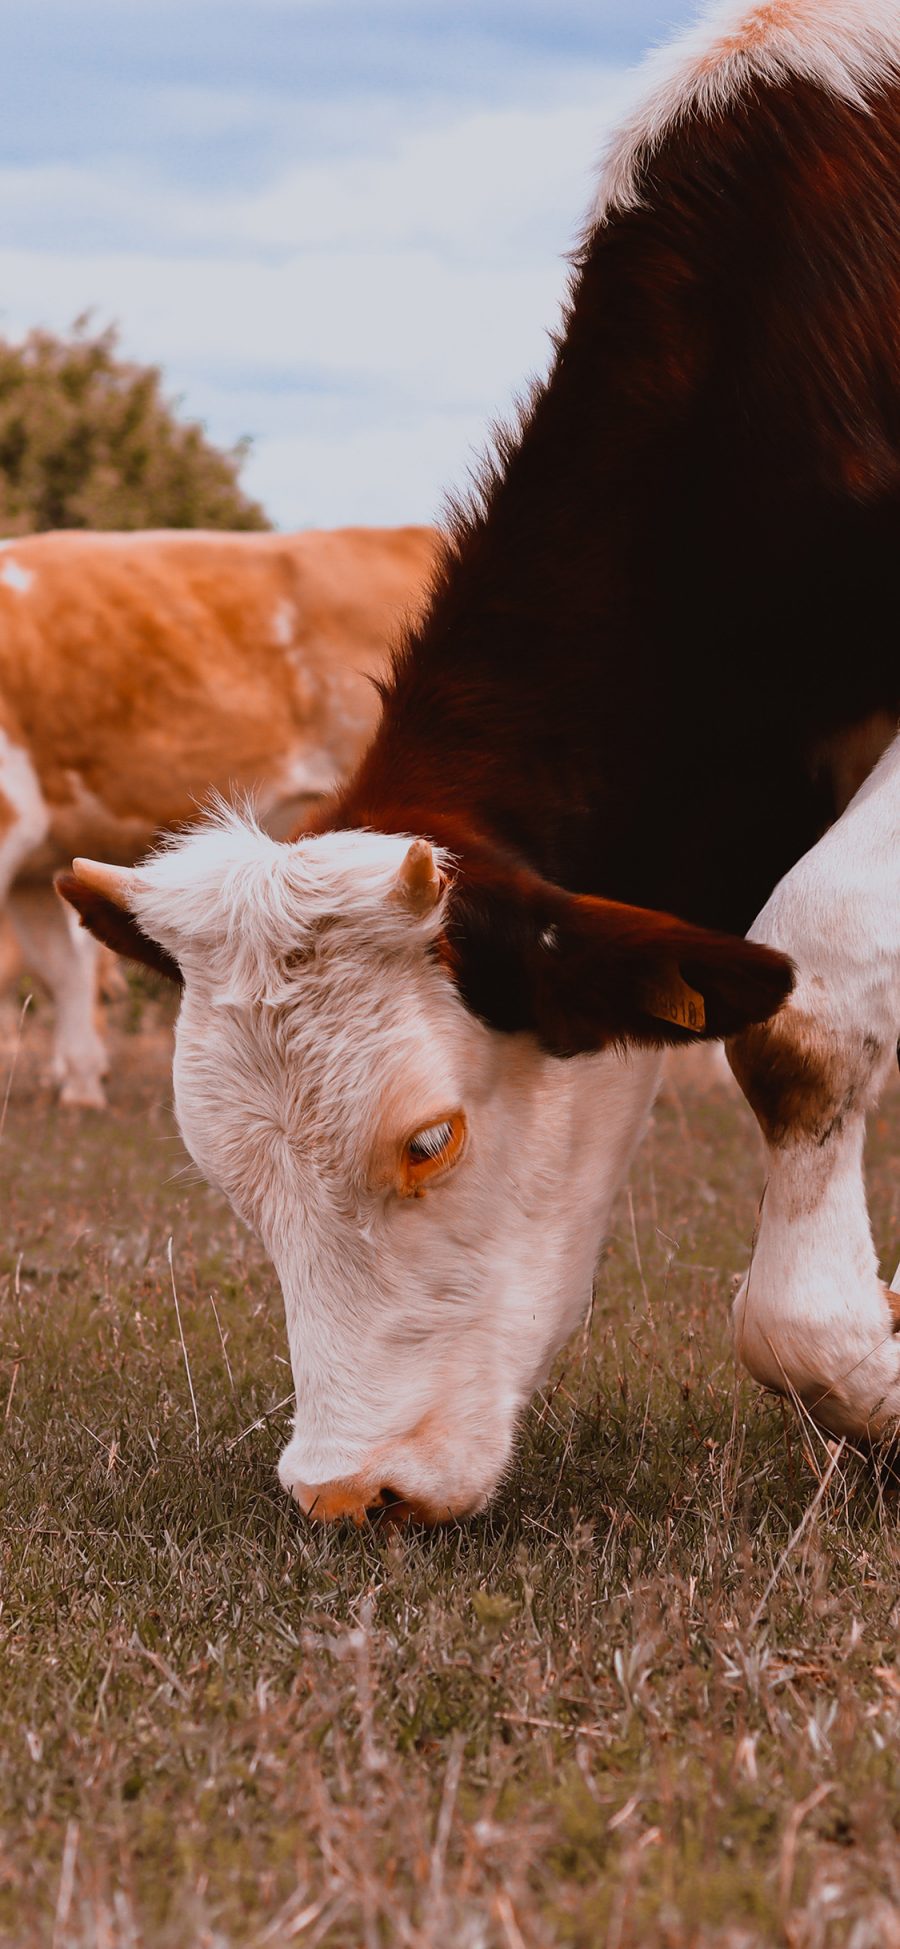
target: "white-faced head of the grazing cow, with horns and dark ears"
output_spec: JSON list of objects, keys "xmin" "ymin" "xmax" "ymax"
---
[{"xmin": 62, "ymin": 815, "xmax": 791, "ymax": 1522}]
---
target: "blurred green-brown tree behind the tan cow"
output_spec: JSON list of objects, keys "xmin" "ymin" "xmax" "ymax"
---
[{"xmin": 0, "ymin": 316, "xmax": 271, "ymax": 536}]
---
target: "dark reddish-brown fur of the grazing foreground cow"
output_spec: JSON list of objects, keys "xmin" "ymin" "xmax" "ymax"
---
[{"xmin": 63, "ymin": 53, "xmax": 900, "ymax": 1060}]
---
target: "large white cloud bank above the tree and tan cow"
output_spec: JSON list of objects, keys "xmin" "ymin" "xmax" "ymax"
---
[{"xmin": 0, "ymin": 68, "xmax": 629, "ymax": 526}]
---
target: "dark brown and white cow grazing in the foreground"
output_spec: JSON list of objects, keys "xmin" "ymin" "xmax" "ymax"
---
[{"xmin": 66, "ymin": 0, "xmax": 900, "ymax": 1520}]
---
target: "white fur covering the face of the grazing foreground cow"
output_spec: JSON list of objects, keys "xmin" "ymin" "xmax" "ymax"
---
[{"xmin": 124, "ymin": 817, "xmax": 658, "ymax": 1512}]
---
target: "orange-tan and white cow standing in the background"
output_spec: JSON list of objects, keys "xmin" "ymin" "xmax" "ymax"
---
[{"xmin": 0, "ymin": 528, "xmax": 436, "ymax": 1107}]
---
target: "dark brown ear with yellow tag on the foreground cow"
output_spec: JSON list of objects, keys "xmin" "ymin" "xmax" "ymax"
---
[{"xmin": 448, "ymin": 873, "xmax": 793, "ymax": 1056}]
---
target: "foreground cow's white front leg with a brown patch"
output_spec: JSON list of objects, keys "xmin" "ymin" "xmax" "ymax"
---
[{"xmin": 729, "ymin": 739, "xmax": 900, "ymax": 1434}]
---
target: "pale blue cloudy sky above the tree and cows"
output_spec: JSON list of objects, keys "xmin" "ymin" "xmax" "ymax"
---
[{"xmin": 0, "ymin": 0, "xmax": 695, "ymax": 528}]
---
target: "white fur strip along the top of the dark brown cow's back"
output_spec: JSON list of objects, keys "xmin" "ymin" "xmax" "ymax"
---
[{"xmin": 594, "ymin": 0, "xmax": 900, "ymax": 220}]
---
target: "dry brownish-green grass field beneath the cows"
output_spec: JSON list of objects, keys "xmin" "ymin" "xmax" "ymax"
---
[{"xmin": 0, "ymin": 990, "xmax": 900, "ymax": 1949}]
